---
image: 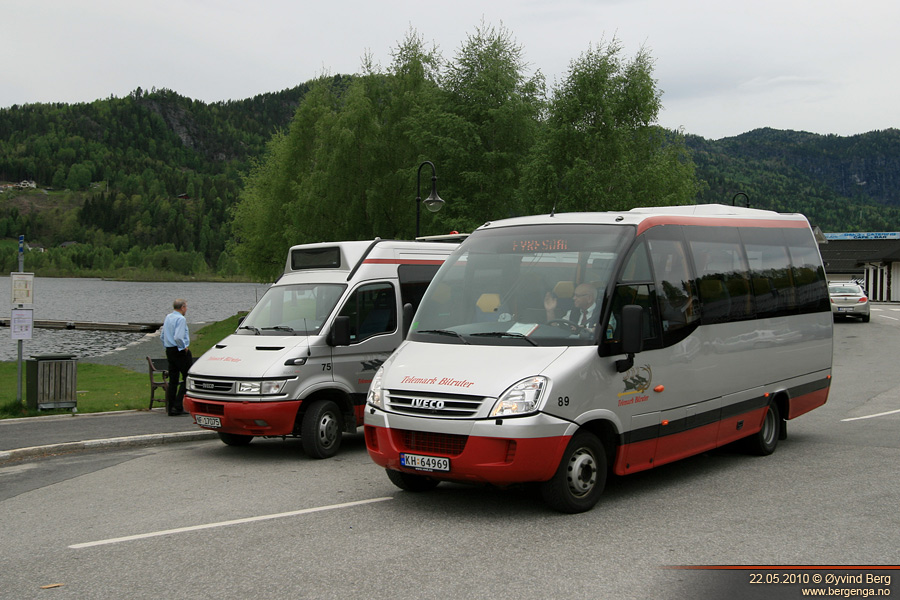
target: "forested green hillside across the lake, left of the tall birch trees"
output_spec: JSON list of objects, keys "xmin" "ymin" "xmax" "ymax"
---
[{"xmin": 0, "ymin": 82, "xmax": 340, "ymax": 276}]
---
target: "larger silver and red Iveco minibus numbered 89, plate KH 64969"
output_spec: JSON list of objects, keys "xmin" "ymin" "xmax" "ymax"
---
[{"xmin": 365, "ymin": 205, "xmax": 832, "ymax": 512}]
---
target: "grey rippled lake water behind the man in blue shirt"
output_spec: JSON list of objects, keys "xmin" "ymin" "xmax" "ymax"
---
[{"xmin": 0, "ymin": 277, "xmax": 269, "ymax": 361}]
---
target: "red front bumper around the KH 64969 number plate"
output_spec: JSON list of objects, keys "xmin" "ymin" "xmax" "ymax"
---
[{"xmin": 365, "ymin": 425, "xmax": 569, "ymax": 485}]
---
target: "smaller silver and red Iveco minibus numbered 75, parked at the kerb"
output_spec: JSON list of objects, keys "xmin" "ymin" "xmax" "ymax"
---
[{"xmin": 184, "ymin": 239, "xmax": 457, "ymax": 458}]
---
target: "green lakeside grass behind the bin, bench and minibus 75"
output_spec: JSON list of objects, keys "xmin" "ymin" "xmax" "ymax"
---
[{"xmin": 0, "ymin": 315, "xmax": 242, "ymax": 419}]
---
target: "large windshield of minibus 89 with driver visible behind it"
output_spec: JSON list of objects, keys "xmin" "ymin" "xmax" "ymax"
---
[{"xmin": 410, "ymin": 225, "xmax": 634, "ymax": 346}]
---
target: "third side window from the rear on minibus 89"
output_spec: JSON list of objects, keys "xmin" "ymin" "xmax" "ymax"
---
[{"xmin": 685, "ymin": 227, "xmax": 755, "ymax": 324}]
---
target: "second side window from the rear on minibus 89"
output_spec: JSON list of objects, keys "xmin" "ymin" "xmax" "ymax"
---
[{"xmin": 741, "ymin": 227, "xmax": 797, "ymax": 319}]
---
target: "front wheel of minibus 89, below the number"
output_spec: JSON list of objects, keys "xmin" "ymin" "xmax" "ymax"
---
[{"xmin": 540, "ymin": 431, "xmax": 607, "ymax": 514}]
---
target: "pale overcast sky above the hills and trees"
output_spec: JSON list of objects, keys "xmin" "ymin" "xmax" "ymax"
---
[{"xmin": 7, "ymin": 0, "xmax": 900, "ymax": 139}]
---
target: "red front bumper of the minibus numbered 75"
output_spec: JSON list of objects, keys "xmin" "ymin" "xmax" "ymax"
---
[{"xmin": 184, "ymin": 396, "xmax": 302, "ymax": 436}]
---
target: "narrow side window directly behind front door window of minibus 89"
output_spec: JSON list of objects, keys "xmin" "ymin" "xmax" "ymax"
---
[{"xmin": 649, "ymin": 233, "xmax": 700, "ymax": 346}]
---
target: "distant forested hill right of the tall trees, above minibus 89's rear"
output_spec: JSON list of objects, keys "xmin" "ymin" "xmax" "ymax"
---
[{"xmin": 686, "ymin": 129, "xmax": 900, "ymax": 231}]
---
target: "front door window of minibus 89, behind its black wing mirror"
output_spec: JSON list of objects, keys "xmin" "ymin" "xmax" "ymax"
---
[{"xmin": 602, "ymin": 242, "xmax": 659, "ymax": 346}]
